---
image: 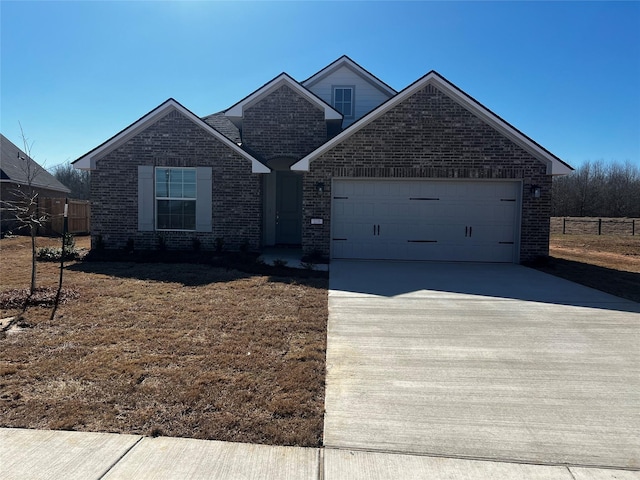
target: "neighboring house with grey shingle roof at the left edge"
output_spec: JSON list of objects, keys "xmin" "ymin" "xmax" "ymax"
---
[{"xmin": 0, "ymin": 134, "xmax": 71, "ymax": 232}]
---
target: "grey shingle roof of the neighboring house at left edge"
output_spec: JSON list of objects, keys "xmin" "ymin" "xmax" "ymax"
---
[{"xmin": 0, "ymin": 134, "xmax": 71, "ymax": 193}]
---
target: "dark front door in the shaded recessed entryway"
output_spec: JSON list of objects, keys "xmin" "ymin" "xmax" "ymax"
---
[{"xmin": 276, "ymin": 172, "xmax": 302, "ymax": 245}]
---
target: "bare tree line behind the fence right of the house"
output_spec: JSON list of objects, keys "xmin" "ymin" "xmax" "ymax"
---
[{"xmin": 551, "ymin": 161, "xmax": 640, "ymax": 217}]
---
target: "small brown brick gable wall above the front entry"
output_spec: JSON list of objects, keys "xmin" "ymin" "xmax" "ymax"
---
[{"xmin": 242, "ymin": 85, "xmax": 327, "ymax": 160}]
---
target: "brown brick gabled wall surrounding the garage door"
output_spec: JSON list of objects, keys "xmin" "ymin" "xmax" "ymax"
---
[{"xmin": 302, "ymin": 85, "xmax": 551, "ymax": 262}]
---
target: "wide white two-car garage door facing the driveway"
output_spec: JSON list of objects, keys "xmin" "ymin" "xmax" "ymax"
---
[{"xmin": 331, "ymin": 180, "xmax": 521, "ymax": 262}]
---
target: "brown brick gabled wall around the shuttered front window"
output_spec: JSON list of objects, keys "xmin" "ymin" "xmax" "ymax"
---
[{"xmin": 91, "ymin": 111, "xmax": 262, "ymax": 250}]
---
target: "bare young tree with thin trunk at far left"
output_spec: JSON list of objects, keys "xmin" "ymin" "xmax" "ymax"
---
[{"xmin": 0, "ymin": 125, "xmax": 48, "ymax": 295}]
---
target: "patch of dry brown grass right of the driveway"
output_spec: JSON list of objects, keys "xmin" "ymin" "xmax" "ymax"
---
[{"xmin": 539, "ymin": 234, "xmax": 640, "ymax": 302}]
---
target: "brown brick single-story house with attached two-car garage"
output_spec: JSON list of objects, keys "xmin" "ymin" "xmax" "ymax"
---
[{"xmin": 74, "ymin": 56, "xmax": 572, "ymax": 263}]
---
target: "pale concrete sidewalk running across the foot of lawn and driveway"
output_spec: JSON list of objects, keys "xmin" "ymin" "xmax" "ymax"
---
[{"xmin": 0, "ymin": 428, "xmax": 640, "ymax": 480}]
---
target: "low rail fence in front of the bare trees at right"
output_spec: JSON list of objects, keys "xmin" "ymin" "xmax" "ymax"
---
[{"xmin": 551, "ymin": 217, "xmax": 640, "ymax": 235}]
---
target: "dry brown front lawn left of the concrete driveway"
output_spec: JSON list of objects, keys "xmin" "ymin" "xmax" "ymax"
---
[{"xmin": 0, "ymin": 238, "xmax": 327, "ymax": 446}]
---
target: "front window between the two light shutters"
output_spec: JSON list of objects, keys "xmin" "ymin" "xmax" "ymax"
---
[{"xmin": 156, "ymin": 168, "xmax": 196, "ymax": 230}]
